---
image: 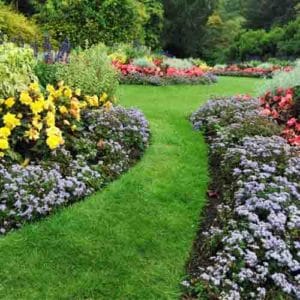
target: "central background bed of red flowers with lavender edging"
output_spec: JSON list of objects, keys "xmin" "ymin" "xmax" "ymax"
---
[{"xmin": 113, "ymin": 60, "xmax": 216, "ymax": 85}]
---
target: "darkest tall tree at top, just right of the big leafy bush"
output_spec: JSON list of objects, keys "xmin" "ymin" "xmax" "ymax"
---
[{"xmin": 163, "ymin": 0, "xmax": 217, "ymax": 57}]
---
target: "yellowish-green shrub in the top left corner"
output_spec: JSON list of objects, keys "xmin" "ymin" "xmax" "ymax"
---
[{"xmin": 0, "ymin": 2, "xmax": 41, "ymax": 43}]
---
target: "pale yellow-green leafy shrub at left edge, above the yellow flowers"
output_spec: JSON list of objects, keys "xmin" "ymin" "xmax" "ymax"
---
[{"xmin": 0, "ymin": 43, "xmax": 37, "ymax": 97}]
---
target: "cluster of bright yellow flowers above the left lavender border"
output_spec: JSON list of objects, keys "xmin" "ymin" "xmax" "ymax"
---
[{"xmin": 0, "ymin": 82, "xmax": 112, "ymax": 157}]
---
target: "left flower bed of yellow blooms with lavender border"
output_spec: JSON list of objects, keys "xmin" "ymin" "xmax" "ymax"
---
[{"xmin": 0, "ymin": 83, "xmax": 149, "ymax": 234}]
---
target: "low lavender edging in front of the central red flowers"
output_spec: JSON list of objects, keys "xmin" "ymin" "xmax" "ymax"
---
[{"xmin": 120, "ymin": 72, "xmax": 217, "ymax": 86}]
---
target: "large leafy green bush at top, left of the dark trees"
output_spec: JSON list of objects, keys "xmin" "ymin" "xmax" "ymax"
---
[{"xmin": 36, "ymin": 0, "xmax": 151, "ymax": 47}]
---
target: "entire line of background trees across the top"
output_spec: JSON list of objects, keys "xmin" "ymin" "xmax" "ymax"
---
[{"xmin": 0, "ymin": 0, "xmax": 300, "ymax": 63}]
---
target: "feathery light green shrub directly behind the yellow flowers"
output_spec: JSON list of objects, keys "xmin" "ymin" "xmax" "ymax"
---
[{"xmin": 56, "ymin": 44, "xmax": 118, "ymax": 97}]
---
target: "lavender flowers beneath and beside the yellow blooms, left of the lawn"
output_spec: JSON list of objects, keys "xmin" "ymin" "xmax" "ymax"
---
[{"xmin": 0, "ymin": 107, "xmax": 150, "ymax": 234}]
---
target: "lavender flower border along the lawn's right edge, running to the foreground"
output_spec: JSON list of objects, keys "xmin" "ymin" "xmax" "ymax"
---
[{"xmin": 185, "ymin": 98, "xmax": 300, "ymax": 299}]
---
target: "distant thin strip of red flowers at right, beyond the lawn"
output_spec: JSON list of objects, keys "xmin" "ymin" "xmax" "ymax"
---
[{"xmin": 212, "ymin": 65, "xmax": 292, "ymax": 78}]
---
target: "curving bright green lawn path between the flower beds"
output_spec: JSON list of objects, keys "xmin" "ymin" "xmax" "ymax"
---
[{"xmin": 0, "ymin": 78, "xmax": 259, "ymax": 300}]
